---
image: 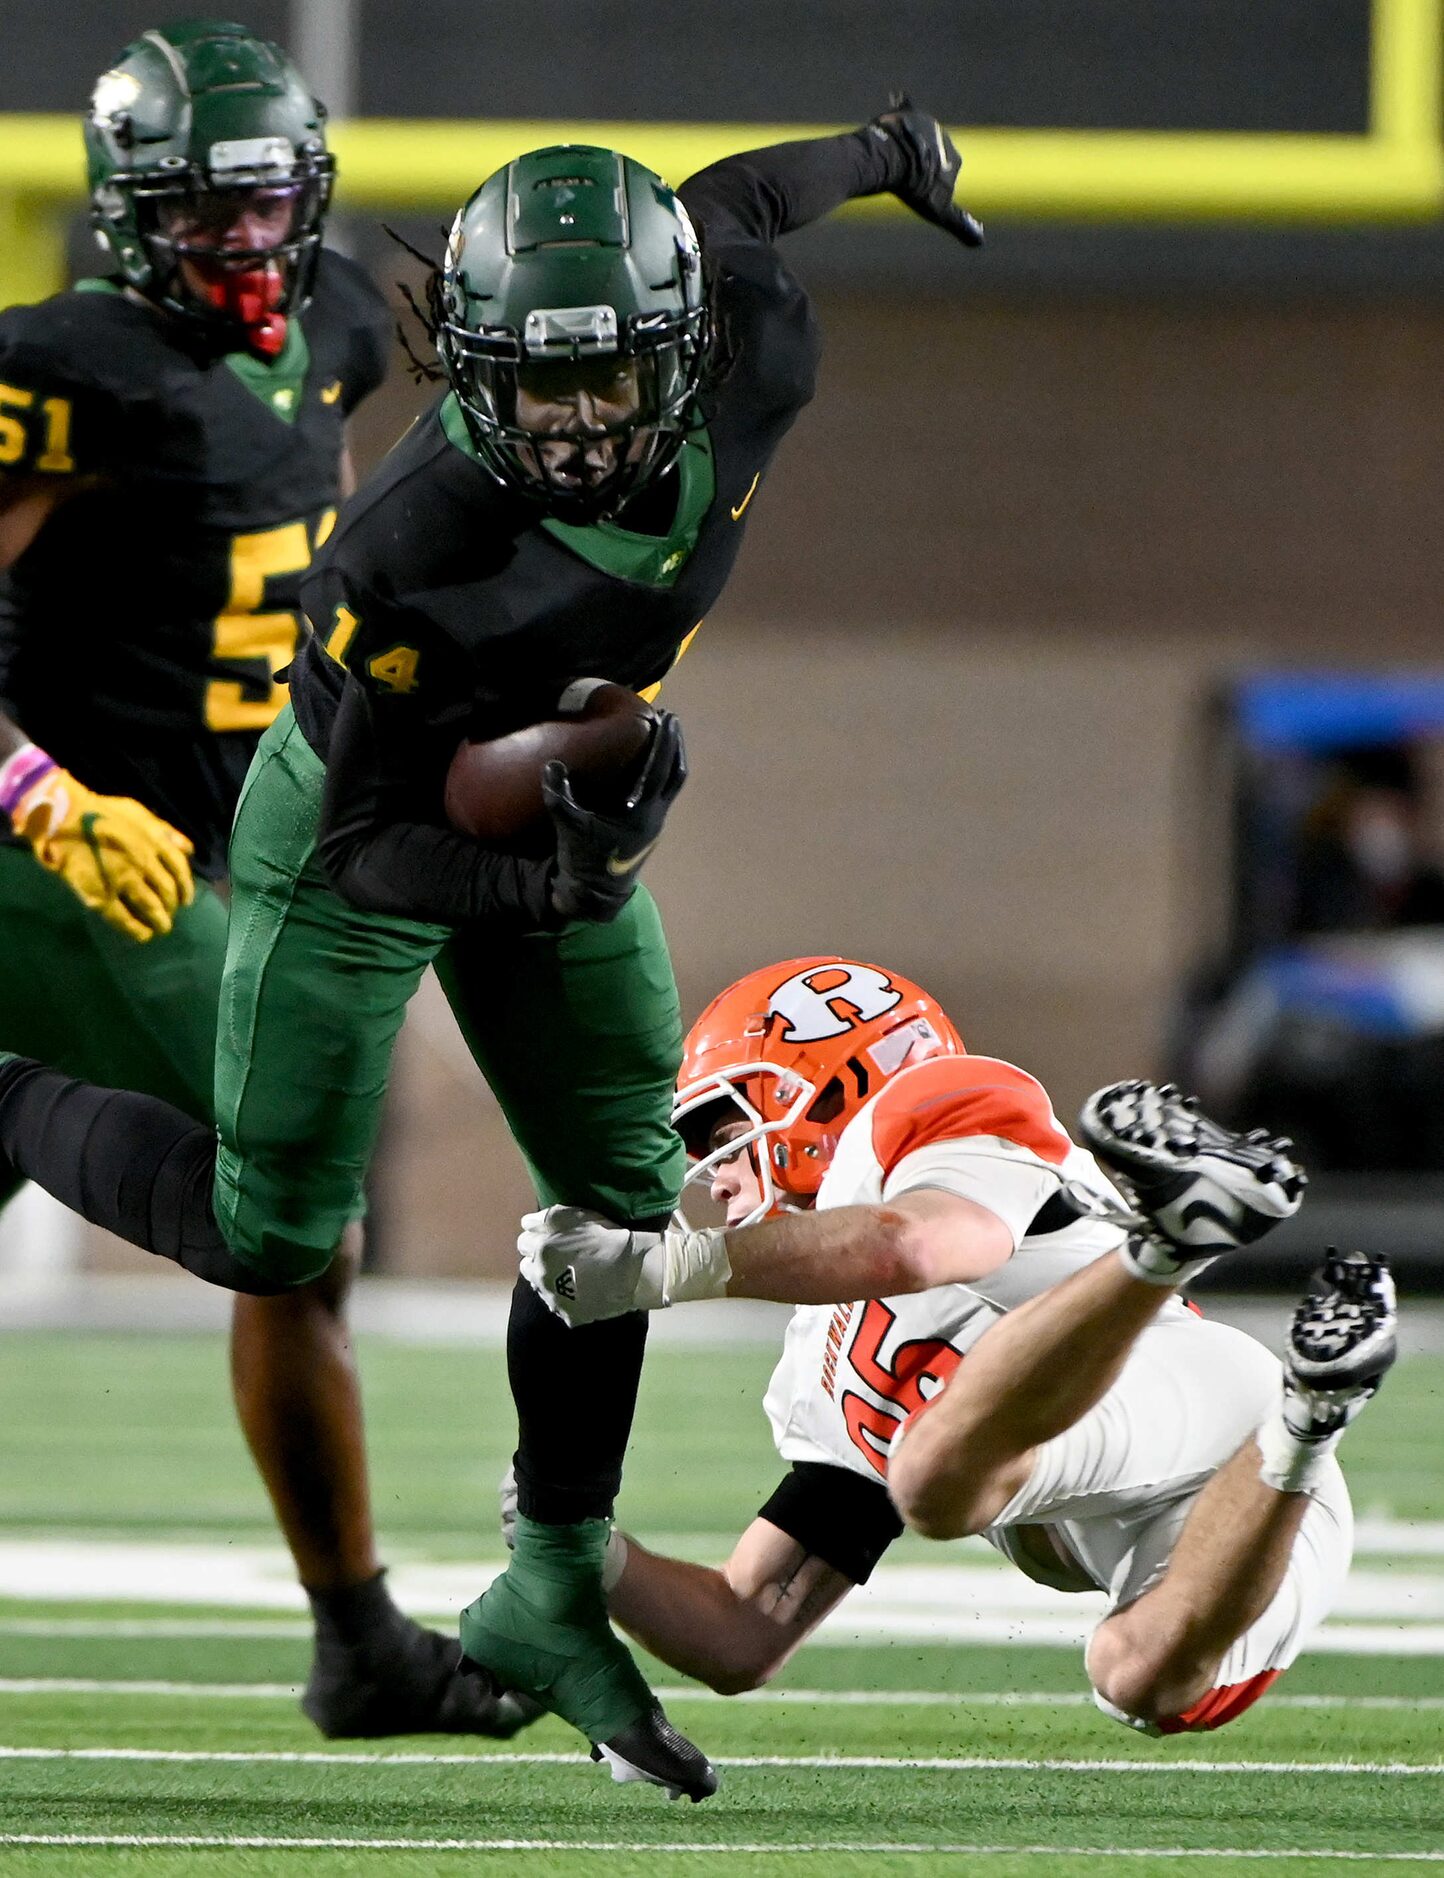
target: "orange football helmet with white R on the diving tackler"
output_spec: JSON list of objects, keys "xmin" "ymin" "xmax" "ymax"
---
[{"xmin": 672, "ymin": 958, "xmax": 967, "ymax": 1224}]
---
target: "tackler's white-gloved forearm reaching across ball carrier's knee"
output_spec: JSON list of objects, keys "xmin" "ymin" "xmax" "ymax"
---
[{"xmin": 516, "ymin": 1189, "xmax": 1014, "ymax": 1326}]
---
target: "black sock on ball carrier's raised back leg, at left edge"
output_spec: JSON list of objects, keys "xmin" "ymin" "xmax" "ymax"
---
[{"xmin": 0, "ymin": 1057, "xmax": 284, "ymax": 1296}]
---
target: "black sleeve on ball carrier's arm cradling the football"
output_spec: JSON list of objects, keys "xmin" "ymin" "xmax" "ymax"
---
[{"xmin": 317, "ymin": 676, "xmax": 563, "ymax": 930}]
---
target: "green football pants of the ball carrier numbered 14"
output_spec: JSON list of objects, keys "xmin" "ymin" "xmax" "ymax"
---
[{"xmin": 216, "ymin": 708, "xmax": 685, "ymax": 1285}]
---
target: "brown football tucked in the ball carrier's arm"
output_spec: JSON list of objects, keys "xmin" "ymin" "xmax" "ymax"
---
[{"xmin": 445, "ymin": 678, "xmax": 657, "ymax": 853}]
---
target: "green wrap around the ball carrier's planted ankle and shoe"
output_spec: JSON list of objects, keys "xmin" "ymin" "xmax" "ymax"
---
[{"xmin": 462, "ymin": 1514, "xmax": 655, "ymax": 1741}]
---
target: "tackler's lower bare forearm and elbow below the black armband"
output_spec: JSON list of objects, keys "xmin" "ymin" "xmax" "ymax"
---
[{"xmin": 607, "ymin": 1519, "xmax": 853, "ymax": 1696}]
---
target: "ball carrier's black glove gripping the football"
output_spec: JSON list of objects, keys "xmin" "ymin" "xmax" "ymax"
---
[{"xmin": 541, "ymin": 712, "xmax": 687, "ymax": 922}]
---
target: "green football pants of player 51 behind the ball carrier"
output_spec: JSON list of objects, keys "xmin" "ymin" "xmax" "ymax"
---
[{"xmin": 0, "ymin": 845, "xmax": 225, "ymax": 1208}]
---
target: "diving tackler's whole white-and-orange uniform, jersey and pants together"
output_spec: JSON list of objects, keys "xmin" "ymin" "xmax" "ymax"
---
[{"xmin": 766, "ymin": 1057, "xmax": 1352, "ymax": 1732}]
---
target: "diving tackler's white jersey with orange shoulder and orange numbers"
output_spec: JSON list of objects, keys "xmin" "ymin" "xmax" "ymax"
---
[{"xmin": 766, "ymin": 1055, "xmax": 1185, "ymax": 1478}]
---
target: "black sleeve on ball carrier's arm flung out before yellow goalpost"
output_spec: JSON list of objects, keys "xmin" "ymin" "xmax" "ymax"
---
[{"xmin": 678, "ymin": 126, "xmax": 903, "ymax": 248}]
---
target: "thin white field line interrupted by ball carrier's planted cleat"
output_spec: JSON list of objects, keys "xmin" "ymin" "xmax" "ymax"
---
[{"xmin": 0, "ymin": 1747, "xmax": 1444, "ymax": 1778}]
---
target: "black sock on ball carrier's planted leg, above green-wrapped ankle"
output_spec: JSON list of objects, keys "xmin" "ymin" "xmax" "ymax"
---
[{"xmin": 507, "ymin": 1279, "xmax": 646, "ymax": 1525}]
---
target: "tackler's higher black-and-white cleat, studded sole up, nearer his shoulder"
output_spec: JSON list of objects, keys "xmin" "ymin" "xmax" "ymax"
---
[{"xmin": 1078, "ymin": 1082, "xmax": 1305, "ymax": 1279}]
